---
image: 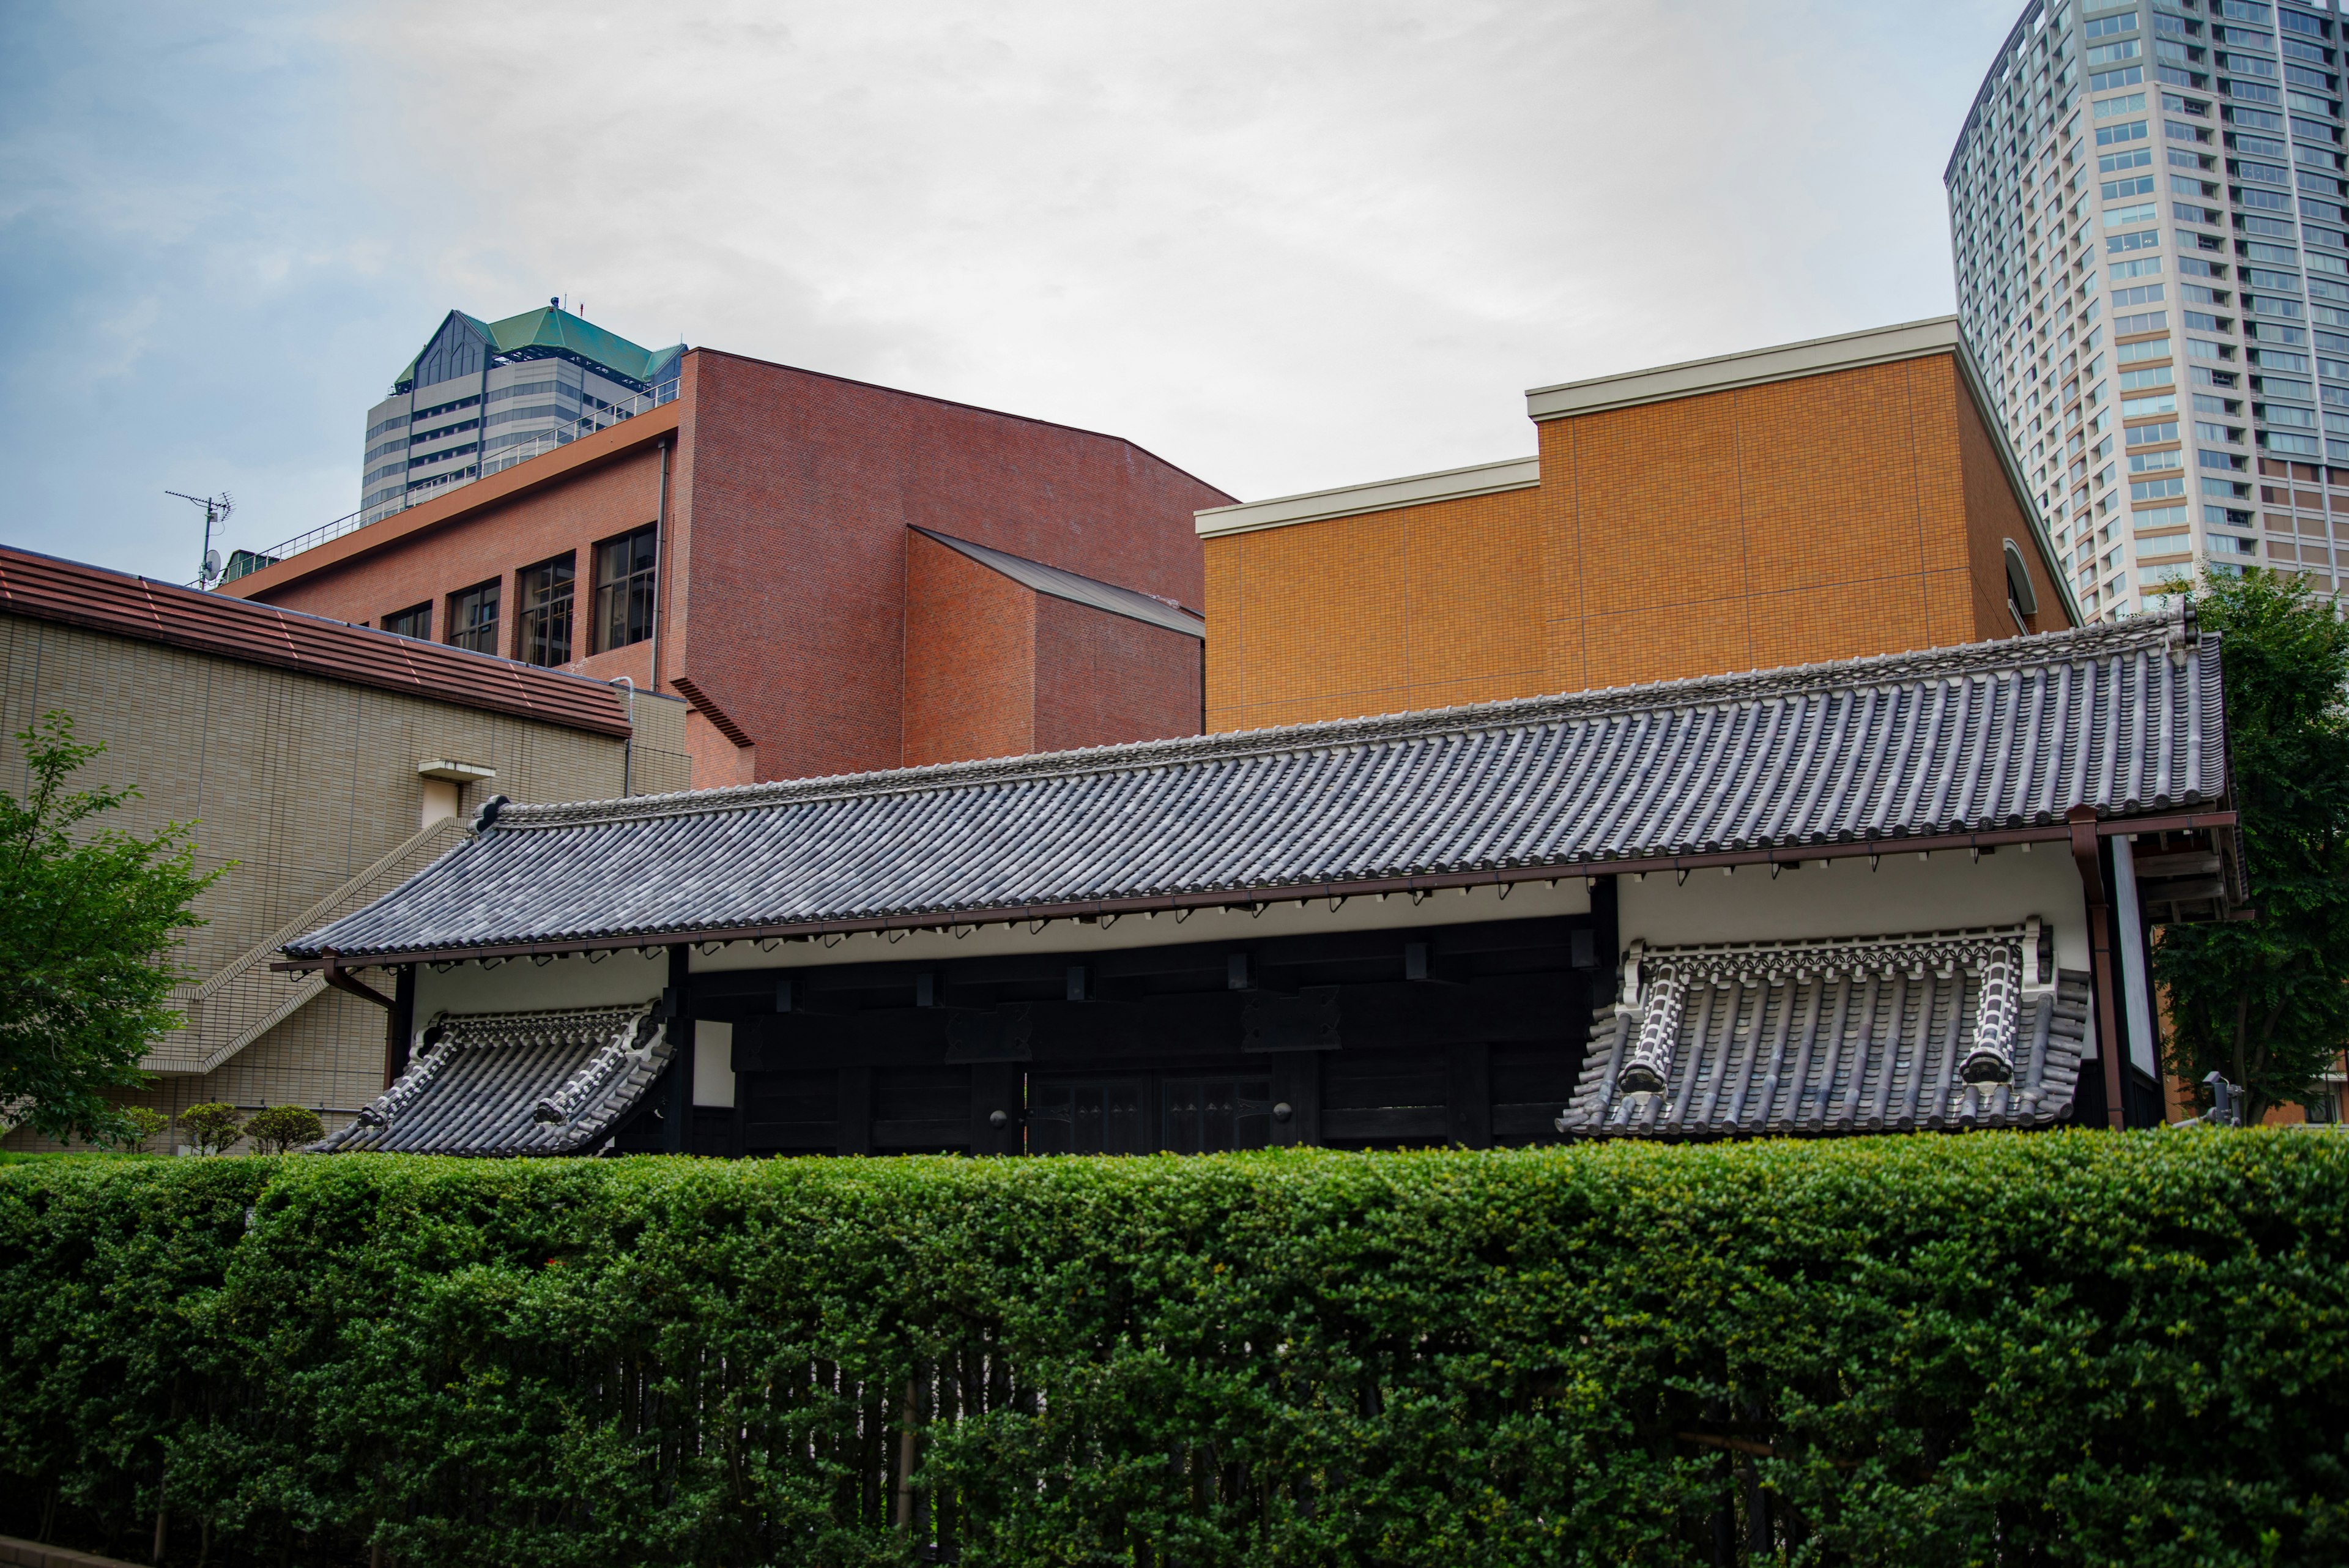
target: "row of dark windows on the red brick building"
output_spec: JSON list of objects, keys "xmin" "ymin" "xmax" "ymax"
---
[{"xmin": 378, "ymin": 524, "xmax": 660, "ymax": 665}]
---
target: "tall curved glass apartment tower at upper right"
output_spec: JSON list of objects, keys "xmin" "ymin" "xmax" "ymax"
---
[{"xmin": 1943, "ymin": 0, "xmax": 2349, "ymax": 619}]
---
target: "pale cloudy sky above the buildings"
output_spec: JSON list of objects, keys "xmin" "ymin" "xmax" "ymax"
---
[{"xmin": 0, "ymin": 0, "xmax": 2020, "ymax": 581}]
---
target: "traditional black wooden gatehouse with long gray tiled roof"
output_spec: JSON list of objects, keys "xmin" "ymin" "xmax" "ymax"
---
[{"xmin": 284, "ymin": 616, "xmax": 2243, "ymax": 1154}]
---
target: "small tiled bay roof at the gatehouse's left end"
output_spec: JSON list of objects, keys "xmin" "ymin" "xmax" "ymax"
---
[{"xmin": 317, "ymin": 1001, "xmax": 669, "ymax": 1154}]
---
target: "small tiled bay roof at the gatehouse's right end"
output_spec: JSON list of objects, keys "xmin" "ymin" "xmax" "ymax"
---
[{"xmin": 1560, "ymin": 921, "xmax": 2088, "ymax": 1138}]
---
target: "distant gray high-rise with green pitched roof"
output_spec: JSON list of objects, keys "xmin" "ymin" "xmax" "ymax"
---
[{"xmin": 360, "ymin": 301, "xmax": 686, "ymax": 519}]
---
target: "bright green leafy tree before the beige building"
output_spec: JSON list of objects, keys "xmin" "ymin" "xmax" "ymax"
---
[{"xmin": 0, "ymin": 712, "xmax": 226, "ymax": 1142}]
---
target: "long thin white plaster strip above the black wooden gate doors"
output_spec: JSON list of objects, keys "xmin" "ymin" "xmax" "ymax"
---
[{"xmin": 693, "ymin": 877, "xmax": 1590, "ymax": 973}]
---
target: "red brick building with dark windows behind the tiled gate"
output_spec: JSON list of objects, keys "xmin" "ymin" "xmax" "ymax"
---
[{"xmin": 226, "ymin": 348, "xmax": 1231, "ymax": 787}]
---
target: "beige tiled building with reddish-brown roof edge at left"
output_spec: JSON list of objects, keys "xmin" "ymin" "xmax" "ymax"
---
[{"xmin": 0, "ymin": 548, "xmax": 688, "ymax": 1150}]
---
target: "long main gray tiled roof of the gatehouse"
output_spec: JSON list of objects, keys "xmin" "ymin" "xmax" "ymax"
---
[{"xmin": 286, "ymin": 614, "xmax": 2227, "ymax": 957}]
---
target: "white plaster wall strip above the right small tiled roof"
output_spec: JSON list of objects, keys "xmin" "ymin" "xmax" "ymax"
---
[{"xmin": 1616, "ymin": 844, "xmax": 2088, "ymax": 968}]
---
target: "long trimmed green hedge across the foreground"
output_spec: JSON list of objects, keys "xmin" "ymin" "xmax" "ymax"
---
[{"xmin": 0, "ymin": 1131, "xmax": 2349, "ymax": 1568}]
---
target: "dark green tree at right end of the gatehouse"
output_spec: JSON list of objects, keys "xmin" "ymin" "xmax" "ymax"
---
[{"xmin": 2154, "ymin": 569, "xmax": 2349, "ymax": 1121}]
